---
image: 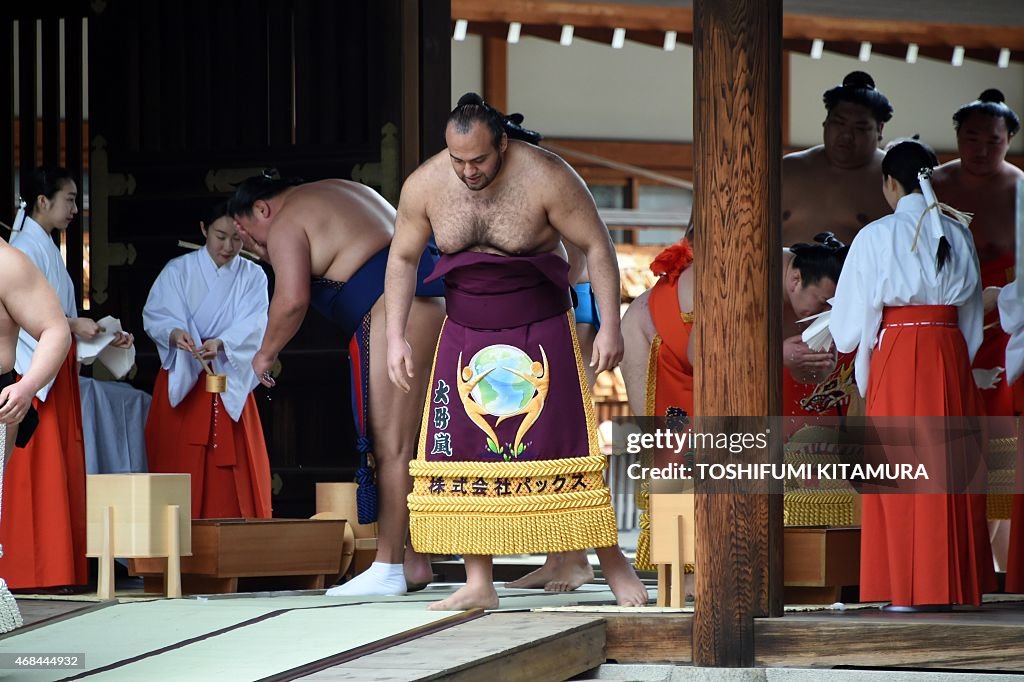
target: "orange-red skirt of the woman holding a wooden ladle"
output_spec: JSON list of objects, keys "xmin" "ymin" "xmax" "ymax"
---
[{"xmin": 145, "ymin": 370, "xmax": 270, "ymax": 518}]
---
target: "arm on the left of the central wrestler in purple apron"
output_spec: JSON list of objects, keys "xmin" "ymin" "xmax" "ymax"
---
[{"xmin": 384, "ymin": 168, "xmax": 431, "ymax": 392}]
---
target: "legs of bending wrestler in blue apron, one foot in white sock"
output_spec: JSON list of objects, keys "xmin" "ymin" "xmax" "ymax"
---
[{"xmin": 328, "ymin": 297, "xmax": 444, "ymax": 596}]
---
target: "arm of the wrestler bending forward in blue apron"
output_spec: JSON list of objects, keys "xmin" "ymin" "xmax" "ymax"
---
[{"xmin": 253, "ymin": 223, "xmax": 310, "ymax": 372}]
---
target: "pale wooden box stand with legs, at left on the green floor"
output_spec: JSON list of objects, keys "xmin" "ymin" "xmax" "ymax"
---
[{"xmin": 85, "ymin": 474, "xmax": 191, "ymax": 599}]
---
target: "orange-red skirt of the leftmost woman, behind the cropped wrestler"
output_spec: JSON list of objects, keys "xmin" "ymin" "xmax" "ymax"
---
[{"xmin": 0, "ymin": 343, "xmax": 89, "ymax": 589}]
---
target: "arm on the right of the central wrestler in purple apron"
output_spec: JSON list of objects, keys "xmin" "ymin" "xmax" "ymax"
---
[{"xmin": 545, "ymin": 158, "xmax": 623, "ymax": 374}]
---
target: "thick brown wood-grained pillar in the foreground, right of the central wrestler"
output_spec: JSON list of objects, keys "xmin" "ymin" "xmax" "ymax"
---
[{"xmin": 692, "ymin": 0, "xmax": 782, "ymax": 667}]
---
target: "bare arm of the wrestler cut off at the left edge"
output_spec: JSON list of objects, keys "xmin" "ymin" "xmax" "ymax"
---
[{"xmin": 0, "ymin": 249, "xmax": 71, "ymax": 424}]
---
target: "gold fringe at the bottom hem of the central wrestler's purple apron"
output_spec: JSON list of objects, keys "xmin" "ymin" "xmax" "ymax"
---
[{"xmin": 410, "ymin": 504, "xmax": 618, "ymax": 555}]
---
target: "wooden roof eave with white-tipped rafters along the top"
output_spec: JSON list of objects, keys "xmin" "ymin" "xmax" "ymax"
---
[{"xmin": 452, "ymin": 0, "xmax": 1024, "ymax": 63}]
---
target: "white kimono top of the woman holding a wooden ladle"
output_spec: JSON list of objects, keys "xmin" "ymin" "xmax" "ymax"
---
[{"xmin": 142, "ymin": 248, "xmax": 269, "ymax": 422}]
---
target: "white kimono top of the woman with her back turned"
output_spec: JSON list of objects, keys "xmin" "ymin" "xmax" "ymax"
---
[{"xmin": 828, "ymin": 193, "xmax": 984, "ymax": 396}]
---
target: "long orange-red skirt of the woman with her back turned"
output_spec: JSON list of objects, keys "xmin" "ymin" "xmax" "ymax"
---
[{"xmin": 860, "ymin": 305, "xmax": 996, "ymax": 606}]
